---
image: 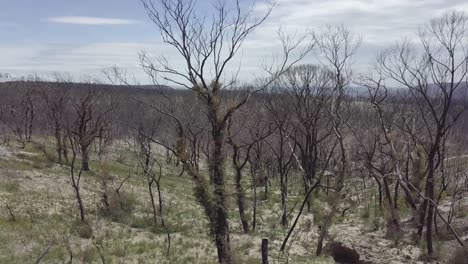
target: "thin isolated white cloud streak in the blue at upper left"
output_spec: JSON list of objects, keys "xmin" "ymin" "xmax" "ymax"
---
[{"xmin": 47, "ymin": 16, "xmax": 140, "ymax": 25}]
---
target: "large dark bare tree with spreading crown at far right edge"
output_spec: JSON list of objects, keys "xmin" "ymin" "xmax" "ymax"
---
[{"xmin": 378, "ymin": 11, "xmax": 468, "ymax": 256}]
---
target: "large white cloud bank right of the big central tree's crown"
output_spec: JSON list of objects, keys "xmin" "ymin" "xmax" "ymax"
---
[{"xmin": 245, "ymin": 0, "xmax": 468, "ymax": 72}]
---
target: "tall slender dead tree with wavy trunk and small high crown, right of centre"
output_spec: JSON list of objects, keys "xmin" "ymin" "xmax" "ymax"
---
[{"xmin": 315, "ymin": 26, "xmax": 361, "ymax": 256}]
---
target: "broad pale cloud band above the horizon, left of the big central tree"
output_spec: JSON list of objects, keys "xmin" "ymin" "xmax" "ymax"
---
[{"xmin": 0, "ymin": 42, "xmax": 183, "ymax": 83}]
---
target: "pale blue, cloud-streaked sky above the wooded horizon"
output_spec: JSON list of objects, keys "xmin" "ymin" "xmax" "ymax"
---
[{"xmin": 0, "ymin": 0, "xmax": 468, "ymax": 82}]
